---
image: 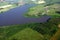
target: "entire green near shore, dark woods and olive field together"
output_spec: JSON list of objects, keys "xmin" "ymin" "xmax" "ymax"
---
[{"xmin": 0, "ymin": 18, "xmax": 60, "ymax": 40}]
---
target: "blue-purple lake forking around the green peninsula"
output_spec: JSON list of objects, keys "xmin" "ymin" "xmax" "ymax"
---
[{"xmin": 0, "ymin": 4, "xmax": 50, "ymax": 26}]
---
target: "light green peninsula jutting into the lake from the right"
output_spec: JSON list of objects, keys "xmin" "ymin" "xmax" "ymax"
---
[{"xmin": 24, "ymin": 4, "xmax": 60, "ymax": 17}]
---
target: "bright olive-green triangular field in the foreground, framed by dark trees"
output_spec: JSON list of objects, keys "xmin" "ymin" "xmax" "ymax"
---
[{"xmin": 9, "ymin": 28, "xmax": 43, "ymax": 40}]
